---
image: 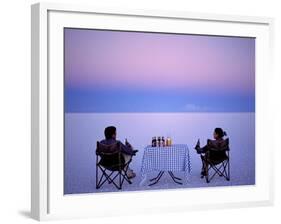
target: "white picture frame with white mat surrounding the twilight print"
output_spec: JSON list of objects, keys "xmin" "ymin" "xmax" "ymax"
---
[{"xmin": 31, "ymin": 3, "xmax": 274, "ymax": 220}]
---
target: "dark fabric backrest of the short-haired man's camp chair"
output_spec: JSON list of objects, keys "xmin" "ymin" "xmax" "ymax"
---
[{"xmin": 96, "ymin": 142, "xmax": 125, "ymax": 168}]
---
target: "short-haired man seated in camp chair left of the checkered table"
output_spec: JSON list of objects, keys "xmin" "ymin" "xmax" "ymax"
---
[{"xmin": 100, "ymin": 126, "xmax": 138, "ymax": 179}]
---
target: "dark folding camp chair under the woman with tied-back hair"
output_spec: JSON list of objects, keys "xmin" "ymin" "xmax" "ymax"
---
[{"xmin": 201, "ymin": 138, "xmax": 230, "ymax": 183}]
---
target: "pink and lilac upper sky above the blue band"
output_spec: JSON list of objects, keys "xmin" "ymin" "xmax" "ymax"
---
[{"xmin": 65, "ymin": 29, "xmax": 255, "ymax": 92}]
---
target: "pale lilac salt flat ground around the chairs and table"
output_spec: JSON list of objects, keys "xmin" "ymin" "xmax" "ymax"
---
[{"xmin": 64, "ymin": 113, "xmax": 255, "ymax": 194}]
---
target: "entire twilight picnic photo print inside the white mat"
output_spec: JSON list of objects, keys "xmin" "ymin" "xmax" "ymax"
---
[{"xmin": 64, "ymin": 28, "xmax": 255, "ymax": 194}]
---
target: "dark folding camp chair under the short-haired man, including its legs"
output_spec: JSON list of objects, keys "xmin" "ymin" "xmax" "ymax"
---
[{"xmin": 96, "ymin": 142, "xmax": 132, "ymax": 190}]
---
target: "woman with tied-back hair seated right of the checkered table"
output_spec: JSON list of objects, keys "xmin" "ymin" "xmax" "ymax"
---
[{"xmin": 195, "ymin": 128, "xmax": 226, "ymax": 177}]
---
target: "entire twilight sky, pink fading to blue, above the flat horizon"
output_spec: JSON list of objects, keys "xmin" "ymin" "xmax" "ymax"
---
[{"xmin": 64, "ymin": 29, "xmax": 255, "ymax": 112}]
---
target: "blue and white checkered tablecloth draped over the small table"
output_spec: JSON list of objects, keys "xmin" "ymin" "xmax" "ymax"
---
[{"xmin": 141, "ymin": 144, "xmax": 191, "ymax": 178}]
